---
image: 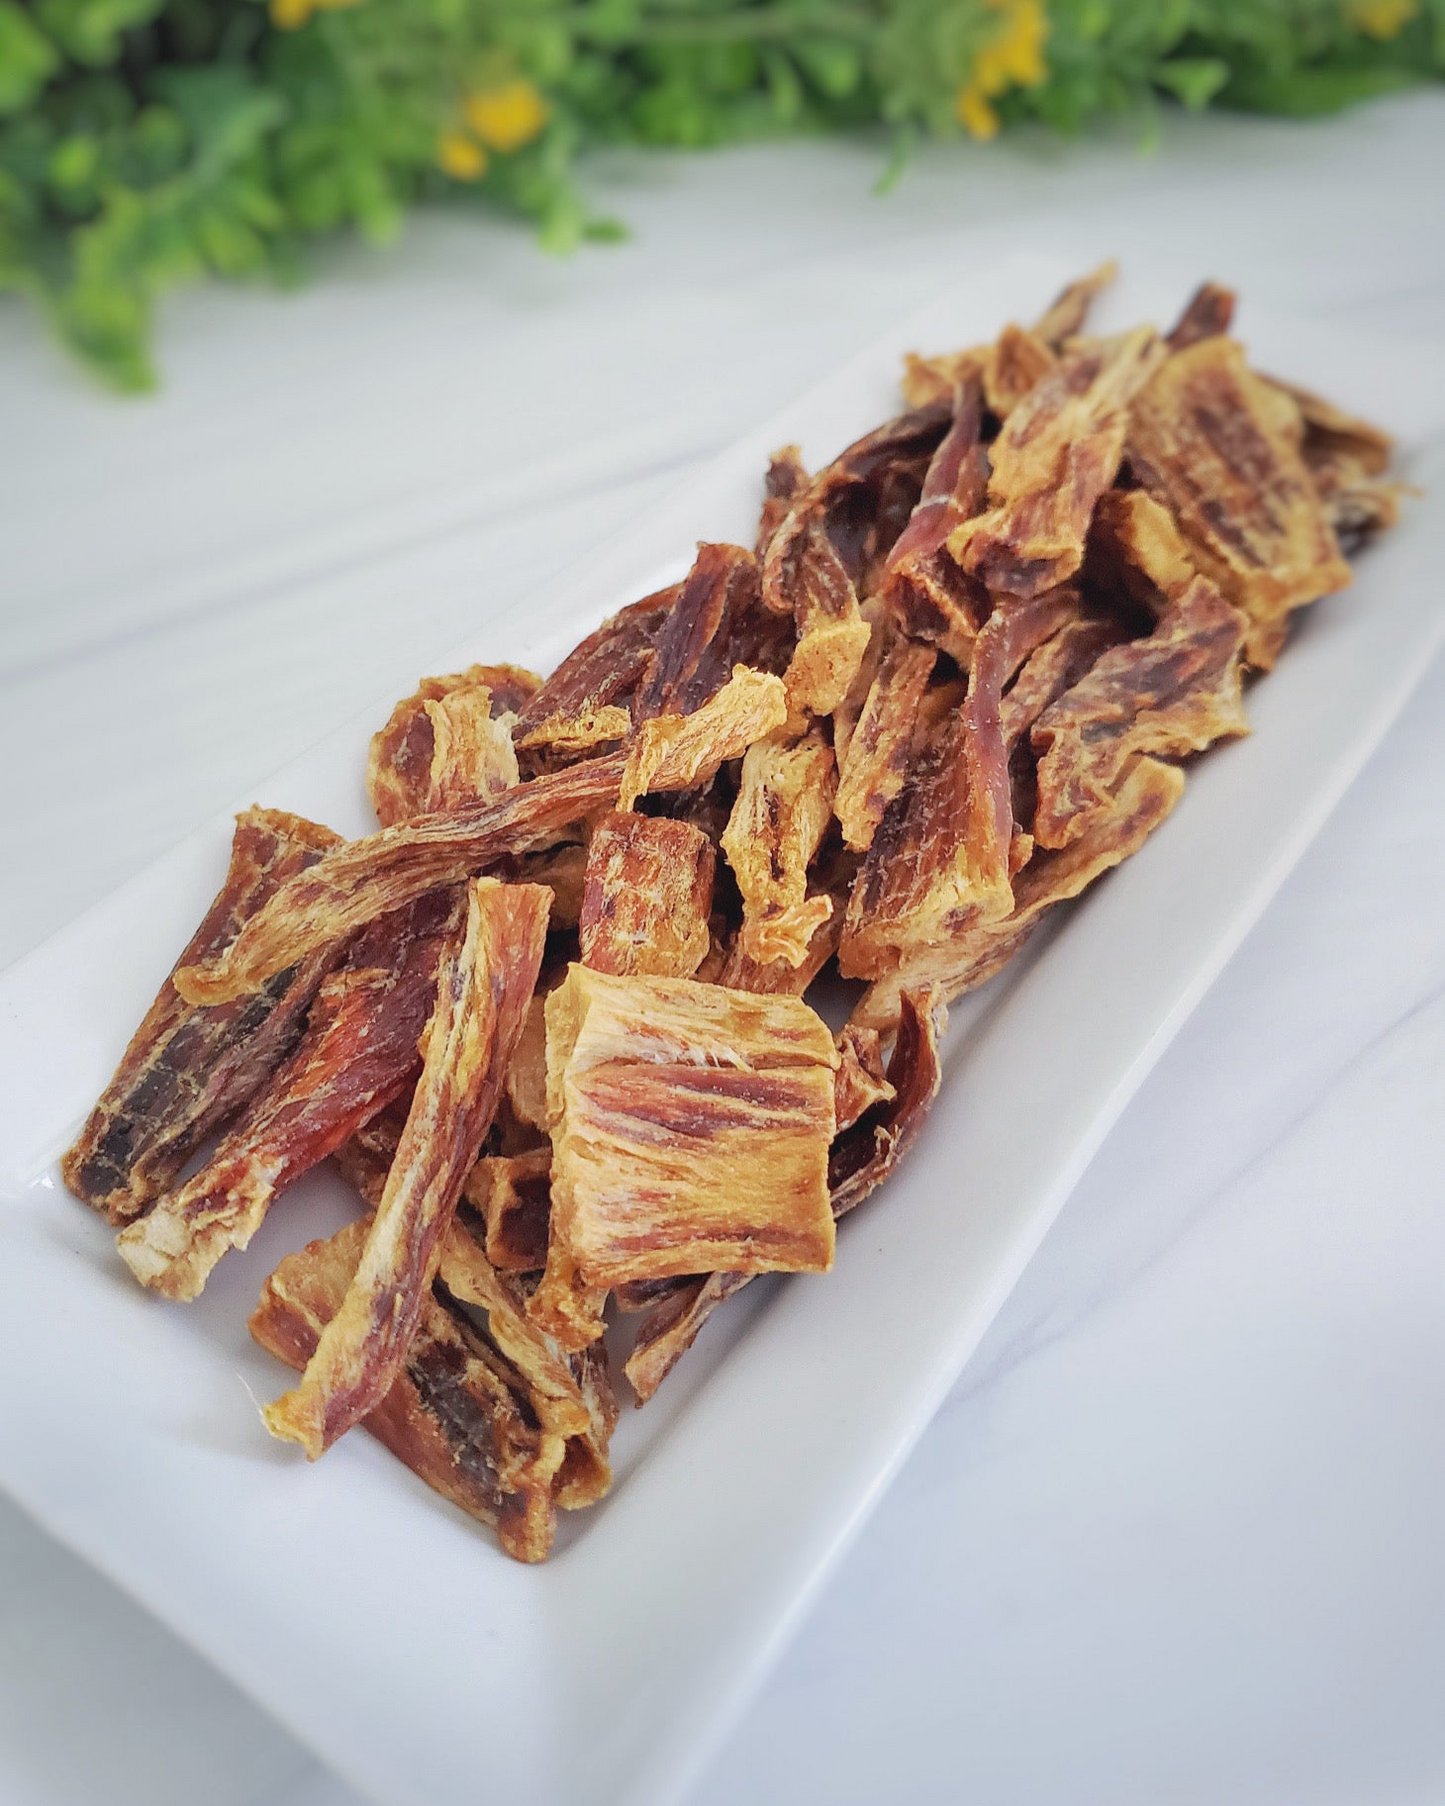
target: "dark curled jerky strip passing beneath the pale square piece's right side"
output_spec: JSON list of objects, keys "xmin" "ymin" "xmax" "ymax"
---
[{"xmin": 623, "ymin": 990, "xmax": 939, "ymax": 1405}]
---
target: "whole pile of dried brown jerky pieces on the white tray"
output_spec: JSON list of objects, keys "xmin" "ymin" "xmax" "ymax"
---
[{"xmin": 63, "ymin": 261, "xmax": 1400, "ymax": 1560}]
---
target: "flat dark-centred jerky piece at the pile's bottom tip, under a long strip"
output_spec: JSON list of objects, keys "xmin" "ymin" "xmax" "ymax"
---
[{"xmin": 249, "ymin": 1221, "xmax": 564, "ymax": 1562}]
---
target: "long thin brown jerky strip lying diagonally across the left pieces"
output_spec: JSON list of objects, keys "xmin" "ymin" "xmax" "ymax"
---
[{"xmin": 175, "ymin": 751, "xmax": 621, "ymax": 1002}]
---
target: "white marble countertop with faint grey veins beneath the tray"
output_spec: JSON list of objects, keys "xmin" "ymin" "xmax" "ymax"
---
[{"xmin": 0, "ymin": 92, "xmax": 1445, "ymax": 1806}]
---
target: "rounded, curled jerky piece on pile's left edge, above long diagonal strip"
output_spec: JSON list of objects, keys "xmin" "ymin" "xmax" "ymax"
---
[{"xmin": 367, "ymin": 665, "xmax": 542, "ymax": 827}]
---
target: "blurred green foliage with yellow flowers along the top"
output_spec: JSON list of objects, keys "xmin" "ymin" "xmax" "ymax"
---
[{"xmin": 0, "ymin": 0, "xmax": 1445, "ymax": 388}]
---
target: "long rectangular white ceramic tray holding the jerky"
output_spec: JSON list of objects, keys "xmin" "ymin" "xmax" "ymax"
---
[{"xmin": 0, "ymin": 260, "xmax": 1445, "ymax": 1806}]
